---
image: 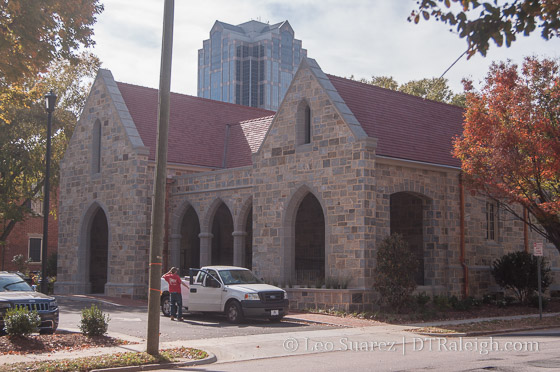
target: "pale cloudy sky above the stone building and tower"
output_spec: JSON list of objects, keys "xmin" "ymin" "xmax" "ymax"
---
[{"xmin": 93, "ymin": 0, "xmax": 560, "ymax": 96}]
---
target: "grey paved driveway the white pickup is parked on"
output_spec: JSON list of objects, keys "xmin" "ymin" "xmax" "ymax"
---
[{"xmin": 56, "ymin": 296, "xmax": 337, "ymax": 342}]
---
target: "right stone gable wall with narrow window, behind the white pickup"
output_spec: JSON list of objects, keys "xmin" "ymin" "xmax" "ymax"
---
[{"xmin": 253, "ymin": 63, "xmax": 376, "ymax": 288}]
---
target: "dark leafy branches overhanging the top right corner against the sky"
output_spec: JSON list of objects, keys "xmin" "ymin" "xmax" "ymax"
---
[{"xmin": 408, "ymin": 0, "xmax": 560, "ymax": 57}]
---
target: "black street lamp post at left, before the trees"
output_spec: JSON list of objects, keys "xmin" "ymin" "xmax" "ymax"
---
[{"xmin": 41, "ymin": 90, "xmax": 56, "ymax": 294}]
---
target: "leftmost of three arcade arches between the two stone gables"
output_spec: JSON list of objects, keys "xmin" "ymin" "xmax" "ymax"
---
[{"xmin": 180, "ymin": 206, "xmax": 200, "ymax": 275}]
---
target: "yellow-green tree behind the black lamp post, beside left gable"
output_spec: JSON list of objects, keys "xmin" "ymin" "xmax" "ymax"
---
[{"xmin": 0, "ymin": 53, "xmax": 100, "ymax": 266}]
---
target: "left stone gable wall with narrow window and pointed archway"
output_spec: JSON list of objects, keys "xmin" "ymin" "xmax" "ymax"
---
[{"xmin": 55, "ymin": 71, "xmax": 152, "ymax": 297}]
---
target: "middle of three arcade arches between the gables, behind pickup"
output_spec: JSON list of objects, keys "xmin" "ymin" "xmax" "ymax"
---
[{"xmin": 211, "ymin": 203, "xmax": 233, "ymax": 265}]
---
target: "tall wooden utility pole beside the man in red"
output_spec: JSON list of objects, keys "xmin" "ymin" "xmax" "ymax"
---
[{"xmin": 146, "ymin": 0, "xmax": 175, "ymax": 355}]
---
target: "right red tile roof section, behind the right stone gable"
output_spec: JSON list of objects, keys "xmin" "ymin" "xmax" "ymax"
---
[{"xmin": 327, "ymin": 75, "xmax": 463, "ymax": 167}]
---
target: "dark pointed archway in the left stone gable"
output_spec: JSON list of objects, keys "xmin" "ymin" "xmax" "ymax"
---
[{"xmin": 89, "ymin": 208, "xmax": 109, "ymax": 293}]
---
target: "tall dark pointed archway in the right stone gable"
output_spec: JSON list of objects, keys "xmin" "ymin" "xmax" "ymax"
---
[{"xmin": 294, "ymin": 193, "xmax": 325, "ymax": 285}]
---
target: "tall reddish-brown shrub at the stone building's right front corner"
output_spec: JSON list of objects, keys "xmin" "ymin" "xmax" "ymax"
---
[{"xmin": 373, "ymin": 234, "xmax": 418, "ymax": 312}]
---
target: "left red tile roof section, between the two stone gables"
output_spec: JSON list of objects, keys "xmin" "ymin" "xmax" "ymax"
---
[{"xmin": 117, "ymin": 83, "xmax": 274, "ymax": 168}]
